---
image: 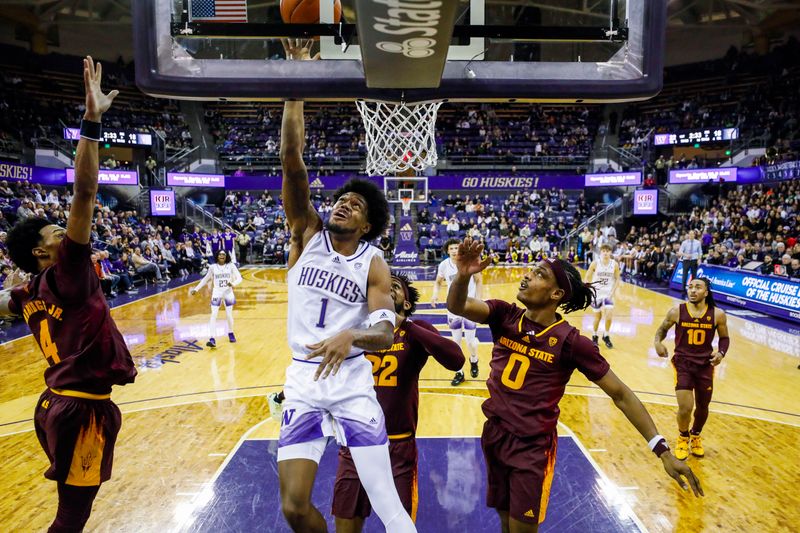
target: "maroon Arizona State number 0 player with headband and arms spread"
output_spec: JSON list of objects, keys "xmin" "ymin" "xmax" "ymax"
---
[{"xmin": 447, "ymin": 239, "xmax": 702, "ymax": 533}]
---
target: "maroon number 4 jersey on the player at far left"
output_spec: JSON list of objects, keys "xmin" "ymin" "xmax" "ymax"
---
[{"xmin": 9, "ymin": 236, "xmax": 136, "ymax": 394}]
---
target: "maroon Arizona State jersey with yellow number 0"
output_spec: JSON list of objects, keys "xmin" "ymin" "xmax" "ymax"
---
[{"xmin": 483, "ymin": 300, "xmax": 609, "ymax": 437}]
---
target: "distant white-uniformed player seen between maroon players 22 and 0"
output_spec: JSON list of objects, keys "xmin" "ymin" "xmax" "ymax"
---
[{"xmin": 431, "ymin": 239, "xmax": 483, "ymax": 387}]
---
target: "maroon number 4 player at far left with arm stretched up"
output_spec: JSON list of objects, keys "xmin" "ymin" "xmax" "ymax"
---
[{"xmin": 0, "ymin": 57, "xmax": 136, "ymax": 532}]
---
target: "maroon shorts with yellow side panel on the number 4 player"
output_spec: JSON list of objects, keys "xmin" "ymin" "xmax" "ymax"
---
[{"xmin": 34, "ymin": 389, "xmax": 122, "ymax": 487}]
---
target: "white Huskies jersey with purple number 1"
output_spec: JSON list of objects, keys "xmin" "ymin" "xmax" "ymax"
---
[{"xmin": 287, "ymin": 230, "xmax": 383, "ymax": 355}]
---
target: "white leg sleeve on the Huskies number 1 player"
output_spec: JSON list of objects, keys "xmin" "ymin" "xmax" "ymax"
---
[{"xmin": 350, "ymin": 444, "xmax": 417, "ymax": 533}]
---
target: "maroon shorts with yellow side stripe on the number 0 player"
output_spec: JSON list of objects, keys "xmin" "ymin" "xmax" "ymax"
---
[{"xmin": 481, "ymin": 419, "xmax": 558, "ymax": 524}]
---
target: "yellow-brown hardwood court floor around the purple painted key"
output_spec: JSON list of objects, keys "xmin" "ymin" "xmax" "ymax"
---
[{"xmin": 0, "ymin": 268, "xmax": 800, "ymax": 532}]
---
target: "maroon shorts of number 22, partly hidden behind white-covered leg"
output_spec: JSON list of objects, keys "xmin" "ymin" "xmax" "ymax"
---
[{"xmin": 332, "ymin": 437, "xmax": 418, "ymax": 520}]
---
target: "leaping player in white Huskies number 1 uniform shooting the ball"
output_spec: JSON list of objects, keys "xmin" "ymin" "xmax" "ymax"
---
[{"xmin": 278, "ymin": 40, "xmax": 416, "ymax": 533}]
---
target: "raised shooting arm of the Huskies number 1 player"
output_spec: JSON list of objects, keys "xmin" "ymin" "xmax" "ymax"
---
[{"xmin": 280, "ymin": 39, "xmax": 322, "ymax": 268}]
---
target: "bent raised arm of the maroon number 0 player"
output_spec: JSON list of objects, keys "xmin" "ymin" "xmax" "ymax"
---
[{"xmin": 447, "ymin": 237, "xmax": 492, "ymax": 323}]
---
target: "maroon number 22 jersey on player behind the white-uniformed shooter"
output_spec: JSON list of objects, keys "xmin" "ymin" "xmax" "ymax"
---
[{"xmin": 367, "ymin": 320, "xmax": 464, "ymax": 438}]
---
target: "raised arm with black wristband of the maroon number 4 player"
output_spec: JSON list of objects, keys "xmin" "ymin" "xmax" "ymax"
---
[{"xmin": 67, "ymin": 56, "xmax": 119, "ymax": 244}]
